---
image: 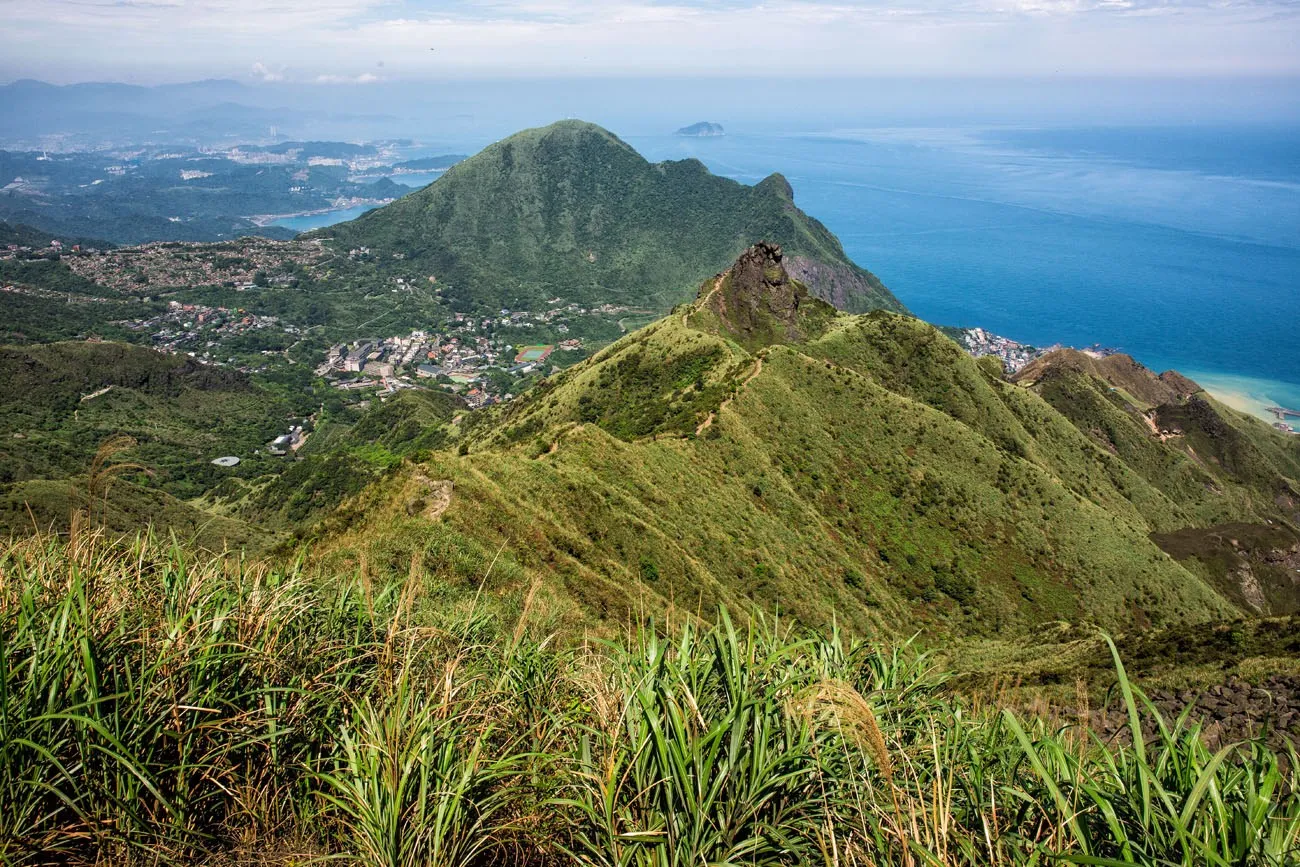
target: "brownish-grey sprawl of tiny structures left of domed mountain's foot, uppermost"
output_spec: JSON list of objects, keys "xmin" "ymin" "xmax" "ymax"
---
[{"xmin": 64, "ymin": 238, "xmax": 330, "ymax": 291}]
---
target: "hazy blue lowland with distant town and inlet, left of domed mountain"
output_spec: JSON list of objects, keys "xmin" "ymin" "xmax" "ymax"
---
[{"xmin": 0, "ymin": 142, "xmax": 462, "ymax": 246}]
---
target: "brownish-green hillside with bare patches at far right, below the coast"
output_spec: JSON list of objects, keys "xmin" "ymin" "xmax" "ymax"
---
[{"xmin": 1015, "ymin": 350, "xmax": 1300, "ymax": 614}]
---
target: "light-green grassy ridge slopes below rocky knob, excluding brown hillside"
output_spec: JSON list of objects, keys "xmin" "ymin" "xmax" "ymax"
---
[{"xmin": 317, "ymin": 300, "xmax": 1235, "ymax": 634}]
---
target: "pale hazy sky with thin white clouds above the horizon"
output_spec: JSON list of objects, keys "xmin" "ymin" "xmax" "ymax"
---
[{"xmin": 0, "ymin": 0, "xmax": 1300, "ymax": 84}]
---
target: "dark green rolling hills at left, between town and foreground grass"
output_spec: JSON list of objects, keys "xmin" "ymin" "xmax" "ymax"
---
[{"xmin": 0, "ymin": 341, "xmax": 478, "ymax": 550}]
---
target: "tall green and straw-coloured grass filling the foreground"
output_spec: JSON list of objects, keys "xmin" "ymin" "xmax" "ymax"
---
[{"xmin": 0, "ymin": 533, "xmax": 1300, "ymax": 866}]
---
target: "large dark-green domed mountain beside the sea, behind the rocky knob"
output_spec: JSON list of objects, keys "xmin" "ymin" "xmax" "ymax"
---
[{"xmin": 315, "ymin": 121, "xmax": 902, "ymax": 311}]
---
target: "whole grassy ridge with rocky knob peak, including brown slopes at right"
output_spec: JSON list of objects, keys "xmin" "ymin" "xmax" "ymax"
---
[{"xmin": 322, "ymin": 246, "xmax": 1300, "ymax": 634}]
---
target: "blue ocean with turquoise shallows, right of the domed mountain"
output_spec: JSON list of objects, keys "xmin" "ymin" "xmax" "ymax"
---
[{"xmin": 299, "ymin": 126, "xmax": 1300, "ymax": 412}]
